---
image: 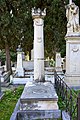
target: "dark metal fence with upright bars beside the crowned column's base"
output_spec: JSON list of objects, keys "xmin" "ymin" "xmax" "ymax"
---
[{"xmin": 54, "ymin": 72, "xmax": 80, "ymax": 120}]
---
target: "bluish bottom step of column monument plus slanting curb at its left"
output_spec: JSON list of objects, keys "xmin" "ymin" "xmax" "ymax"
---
[{"xmin": 10, "ymin": 96, "xmax": 61, "ymax": 120}]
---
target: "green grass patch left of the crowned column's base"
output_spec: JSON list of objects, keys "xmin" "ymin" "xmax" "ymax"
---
[{"xmin": 0, "ymin": 86, "xmax": 24, "ymax": 120}]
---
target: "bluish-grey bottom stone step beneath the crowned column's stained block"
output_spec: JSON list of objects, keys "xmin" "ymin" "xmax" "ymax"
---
[{"xmin": 18, "ymin": 110, "xmax": 61, "ymax": 120}]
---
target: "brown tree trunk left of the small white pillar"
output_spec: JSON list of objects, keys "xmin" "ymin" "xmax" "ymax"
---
[{"xmin": 5, "ymin": 42, "xmax": 12, "ymax": 72}]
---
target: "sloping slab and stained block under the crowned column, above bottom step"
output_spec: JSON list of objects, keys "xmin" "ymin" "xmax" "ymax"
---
[{"xmin": 20, "ymin": 82, "xmax": 58, "ymax": 110}]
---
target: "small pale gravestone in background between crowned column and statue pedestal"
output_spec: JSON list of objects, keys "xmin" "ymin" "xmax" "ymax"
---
[{"xmin": 55, "ymin": 52, "xmax": 62, "ymax": 72}]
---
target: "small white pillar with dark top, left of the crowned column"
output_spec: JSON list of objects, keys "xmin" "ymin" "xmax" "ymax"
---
[{"xmin": 16, "ymin": 45, "xmax": 24, "ymax": 76}]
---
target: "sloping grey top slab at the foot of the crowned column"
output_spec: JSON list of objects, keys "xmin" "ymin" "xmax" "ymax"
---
[{"xmin": 21, "ymin": 82, "xmax": 58, "ymax": 101}]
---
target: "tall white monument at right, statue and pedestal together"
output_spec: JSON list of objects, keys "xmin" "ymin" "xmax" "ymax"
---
[{"xmin": 65, "ymin": 1, "xmax": 80, "ymax": 87}]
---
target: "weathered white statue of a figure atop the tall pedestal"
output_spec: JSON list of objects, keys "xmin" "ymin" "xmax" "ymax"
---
[{"xmin": 66, "ymin": 3, "xmax": 79, "ymax": 33}]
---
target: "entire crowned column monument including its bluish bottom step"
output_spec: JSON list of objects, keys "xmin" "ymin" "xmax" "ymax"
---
[{"xmin": 11, "ymin": 8, "xmax": 60, "ymax": 120}]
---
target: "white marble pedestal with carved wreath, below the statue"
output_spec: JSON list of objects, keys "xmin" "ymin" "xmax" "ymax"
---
[{"xmin": 65, "ymin": 33, "xmax": 80, "ymax": 87}]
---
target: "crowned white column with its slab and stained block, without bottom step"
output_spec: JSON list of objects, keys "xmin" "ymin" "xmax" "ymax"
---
[{"xmin": 20, "ymin": 8, "xmax": 58, "ymax": 113}]
